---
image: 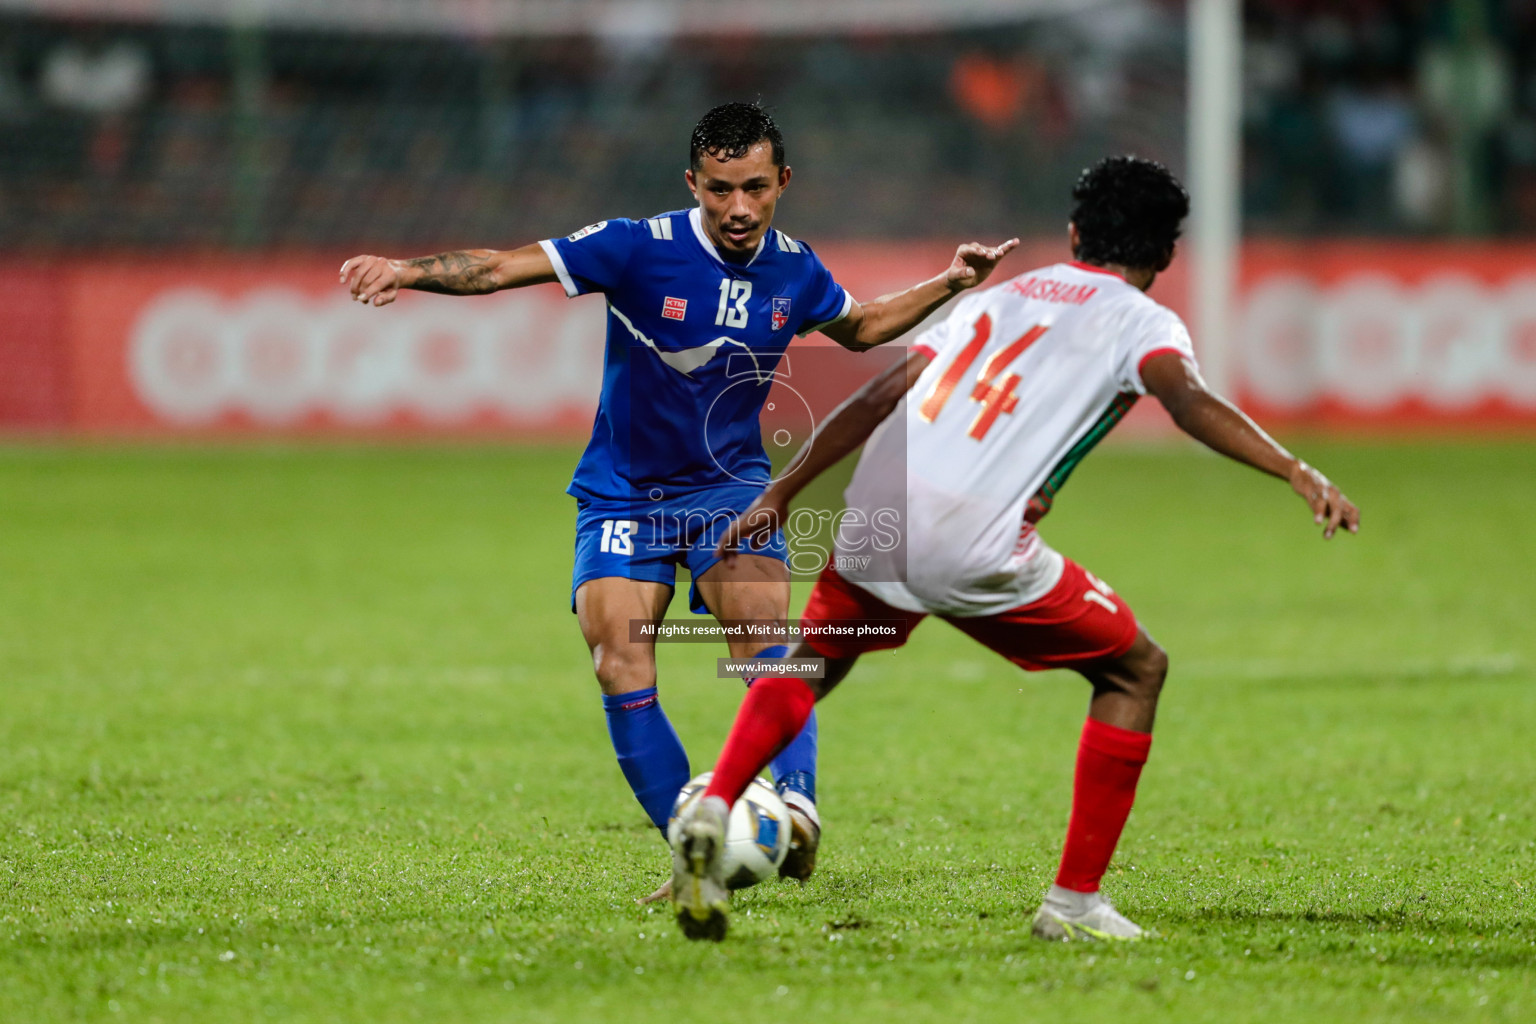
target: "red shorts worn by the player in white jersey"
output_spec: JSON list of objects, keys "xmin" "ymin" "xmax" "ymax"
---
[{"xmin": 800, "ymin": 559, "xmax": 1137, "ymax": 671}]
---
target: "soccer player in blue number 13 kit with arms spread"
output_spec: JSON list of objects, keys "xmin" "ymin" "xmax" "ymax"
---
[{"xmin": 341, "ymin": 103, "xmax": 1018, "ymax": 898}]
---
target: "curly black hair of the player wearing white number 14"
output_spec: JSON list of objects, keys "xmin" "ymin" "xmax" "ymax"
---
[{"xmin": 1072, "ymin": 157, "xmax": 1189, "ymax": 270}]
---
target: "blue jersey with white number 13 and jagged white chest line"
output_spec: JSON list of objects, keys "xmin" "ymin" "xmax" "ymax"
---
[{"xmin": 539, "ymin": 209, "xmax": 852, "ymax": 504}]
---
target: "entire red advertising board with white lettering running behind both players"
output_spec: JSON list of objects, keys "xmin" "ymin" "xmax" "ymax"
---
[{"xmin": 0, "ymin": 239, "xmax": 1536, "ymax": 438}]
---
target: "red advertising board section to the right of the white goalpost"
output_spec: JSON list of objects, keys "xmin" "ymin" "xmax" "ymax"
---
[{"xmin": 1233, "ymin": 243, "xmax": 1536, "ymax": 427}]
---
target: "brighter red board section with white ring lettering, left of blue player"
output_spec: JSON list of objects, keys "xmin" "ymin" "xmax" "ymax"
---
[{"xmin": 56, "ymin": 259, "xmax": 604, "ymax": 434}]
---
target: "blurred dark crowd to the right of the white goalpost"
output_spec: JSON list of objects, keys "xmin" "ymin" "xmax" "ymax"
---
[{"xmin": 1244, "ymin": 0, "xmax": 1536, "ymax": 235}]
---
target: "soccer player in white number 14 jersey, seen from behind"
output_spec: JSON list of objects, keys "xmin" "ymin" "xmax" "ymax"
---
[{"xmin": 673, "ymin": 157, "xmax": 1359, "ymax": 940}]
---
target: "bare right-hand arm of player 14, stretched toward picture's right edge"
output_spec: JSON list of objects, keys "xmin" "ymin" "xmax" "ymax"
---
[{"xmin": 1141, "ymin": 352, "xmax": 1359, "ymax": 540}]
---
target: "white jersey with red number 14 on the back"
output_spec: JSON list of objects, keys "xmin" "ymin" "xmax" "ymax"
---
[{"xmin": 836, "ymin": 263, "xmax": 1193, "ymax": 617}]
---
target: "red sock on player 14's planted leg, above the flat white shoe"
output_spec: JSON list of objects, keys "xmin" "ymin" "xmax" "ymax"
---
[{"xmin": 1057, "ymin": 718, "xmax": 1152, "ymax": 892}]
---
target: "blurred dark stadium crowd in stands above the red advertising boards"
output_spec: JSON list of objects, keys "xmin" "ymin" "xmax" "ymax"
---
[{"xmin": 0, "ymin": 0, "xmax": 1536, "ymax": 252}]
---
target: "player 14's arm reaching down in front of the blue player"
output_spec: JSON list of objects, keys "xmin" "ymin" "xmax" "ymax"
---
[{"xmin": 716, "ymin": 350, "xmax": 929, "ymax": 563}]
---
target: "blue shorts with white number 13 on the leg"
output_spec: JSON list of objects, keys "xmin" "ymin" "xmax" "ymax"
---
[{"xmin": 571, "ymin": 485, "xmax": 788, "ymax": 614}]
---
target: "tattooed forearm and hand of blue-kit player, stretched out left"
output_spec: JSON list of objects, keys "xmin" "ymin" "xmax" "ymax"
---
[{"xmin": 341, "ymin": 244, "xmax": 558, "ymax": 306}]
